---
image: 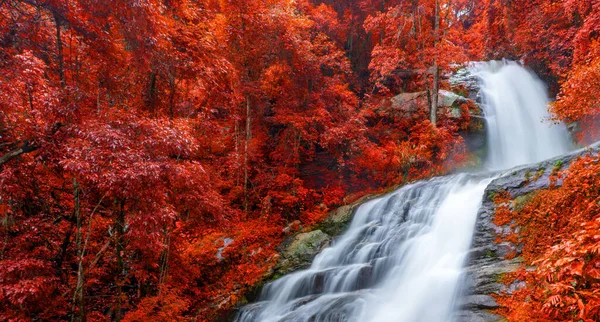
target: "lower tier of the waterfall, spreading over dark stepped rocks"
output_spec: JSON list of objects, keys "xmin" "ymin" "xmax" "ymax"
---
[{"xmin": 238, "ymin": 174, "xmax": 490, "ymax": 322}]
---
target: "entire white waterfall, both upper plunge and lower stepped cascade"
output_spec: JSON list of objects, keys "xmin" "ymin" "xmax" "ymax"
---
[{"xmin": 236, "ymin": 63, "xmax": 569, "ymax": 322}]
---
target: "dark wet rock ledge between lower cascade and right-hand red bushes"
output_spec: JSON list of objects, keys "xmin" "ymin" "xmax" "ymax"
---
[{"xmin": 464, "ymin": 143, "xmax": 600, "ymax": 322}]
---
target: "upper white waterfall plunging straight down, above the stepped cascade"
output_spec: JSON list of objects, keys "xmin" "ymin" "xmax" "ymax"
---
[{"xmin": 473, "ymin": 62, "xmax": 571, "ymax": 170}]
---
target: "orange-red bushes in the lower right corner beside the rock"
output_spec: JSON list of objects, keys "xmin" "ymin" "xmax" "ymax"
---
[{"xmin": 497, "ymin": 157, "xmax": 600, "ymax": 321}]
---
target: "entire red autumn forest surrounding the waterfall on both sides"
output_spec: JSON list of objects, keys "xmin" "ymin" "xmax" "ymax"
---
[{"xmin": 0, "ymin": 0, "xmax": 600, "ymax": 322}]
